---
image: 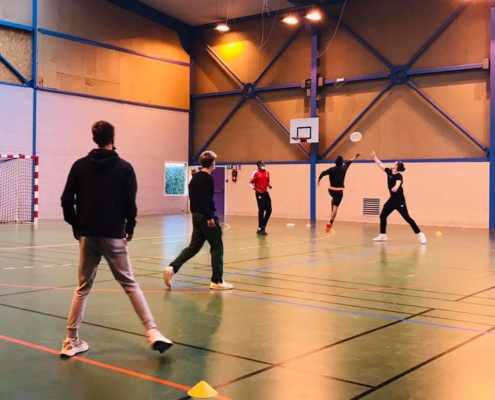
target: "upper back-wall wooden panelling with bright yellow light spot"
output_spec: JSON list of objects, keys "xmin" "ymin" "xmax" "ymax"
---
[{"xmin": 195, "ymin": 18, "xmax": 311, "ymax": 93}]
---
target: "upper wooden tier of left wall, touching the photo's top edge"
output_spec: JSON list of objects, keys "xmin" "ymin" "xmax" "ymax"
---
[{"xmin": 39, "ymin": 0, "xmax": 189, "ymax": 63}]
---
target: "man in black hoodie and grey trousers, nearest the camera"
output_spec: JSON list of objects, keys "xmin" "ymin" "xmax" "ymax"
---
[{"xmin": 61, "ymin": 121, "xmax": 172, "ymax": 357}]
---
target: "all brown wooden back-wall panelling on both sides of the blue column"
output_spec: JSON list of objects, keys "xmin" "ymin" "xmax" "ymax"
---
[{"xmin": 193, "ymin": 0, "xmax": 490, "ymax": 162}]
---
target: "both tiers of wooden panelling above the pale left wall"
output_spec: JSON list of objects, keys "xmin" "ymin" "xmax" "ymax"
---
[{"xmin": 39, "ymin": 0, "xmax": 189, "ymax": 109}]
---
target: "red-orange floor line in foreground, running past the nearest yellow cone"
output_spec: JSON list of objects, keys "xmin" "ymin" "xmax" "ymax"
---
[{"xmin": 0, "ymin": 335, "xmax": 232, "ymax": 400}]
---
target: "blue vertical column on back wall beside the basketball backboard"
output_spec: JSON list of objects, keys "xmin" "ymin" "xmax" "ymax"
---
[{"xmin": 309, "ymin": 32, "xmax": 319, "ymax": 222}]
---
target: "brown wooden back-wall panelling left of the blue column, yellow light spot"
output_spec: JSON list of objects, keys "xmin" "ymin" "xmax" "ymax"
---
[{"xmin": 193, "ymin": 18, "xmax": 311, "ymax": 161}]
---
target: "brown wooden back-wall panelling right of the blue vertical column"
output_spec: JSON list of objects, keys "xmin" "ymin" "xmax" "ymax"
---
[{"xmin": 320, "ymin": 0, "xmax": 490, "ymax": 159}]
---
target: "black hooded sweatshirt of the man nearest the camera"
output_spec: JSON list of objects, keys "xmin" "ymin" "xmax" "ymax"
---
[{"xmin": 61, "ymin": 149, "xmax": 137, "ymax": 239}]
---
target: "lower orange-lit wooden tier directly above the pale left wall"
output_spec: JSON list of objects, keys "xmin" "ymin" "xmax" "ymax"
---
[{"xmin": 39, "ymin": 35, "xmax": 189, "ymax": 108}]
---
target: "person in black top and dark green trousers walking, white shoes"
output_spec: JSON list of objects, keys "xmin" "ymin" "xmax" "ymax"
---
[{"xmin": 163, "ymin": 151, "xmax": 233, "ymax": 290}]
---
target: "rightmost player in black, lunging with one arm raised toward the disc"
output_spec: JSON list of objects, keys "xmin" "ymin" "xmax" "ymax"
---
[{"xmin": 371, "ymin": 151, "xmax": 426, "ymax": 244}]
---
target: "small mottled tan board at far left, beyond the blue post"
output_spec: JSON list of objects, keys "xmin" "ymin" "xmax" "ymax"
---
[{"xmin": 0, "ymin": 26, "xmax": 33, "ymax": 83}]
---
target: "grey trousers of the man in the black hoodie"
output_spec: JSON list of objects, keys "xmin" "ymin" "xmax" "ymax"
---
[{"xmin": 67, "ymin": 237, "xmax": 156, "ymax": 338}]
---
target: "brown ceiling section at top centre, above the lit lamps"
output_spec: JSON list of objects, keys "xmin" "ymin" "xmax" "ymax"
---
[{"xmin": 139, "ymin": 0, "xmax": 294, "ymax": 26}]
